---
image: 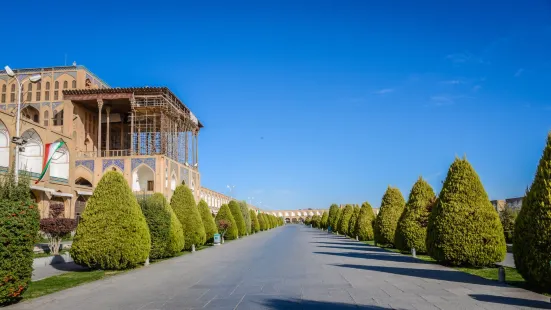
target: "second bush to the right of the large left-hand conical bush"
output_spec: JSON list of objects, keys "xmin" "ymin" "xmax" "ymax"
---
[{"xmin": 170, "ymin": 184, "xmax": 207, "ymax": 251}]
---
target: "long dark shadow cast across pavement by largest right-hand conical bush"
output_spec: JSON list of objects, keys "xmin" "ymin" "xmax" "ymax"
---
[{"xmin": 333, "ymin": 264, "xmax": 507, "ymax": 287}]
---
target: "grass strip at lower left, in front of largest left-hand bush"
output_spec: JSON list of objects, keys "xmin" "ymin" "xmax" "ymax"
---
[{"xmin": 23, "ymin": 270, "xmax": 124, "ymax": 299}]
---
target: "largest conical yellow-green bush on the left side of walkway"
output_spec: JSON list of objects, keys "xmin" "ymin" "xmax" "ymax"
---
[{"xmin": 71, "ymin": 171, "xmax": 151, "ymax": 270}]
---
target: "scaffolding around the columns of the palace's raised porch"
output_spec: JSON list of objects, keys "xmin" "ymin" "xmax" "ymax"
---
[{"xmin": 130, "ymin": 91, "xmax": 199, "ymax": 165}]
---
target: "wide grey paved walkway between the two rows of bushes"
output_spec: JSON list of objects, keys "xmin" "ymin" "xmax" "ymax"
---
[{"xmin": 8, "ymin": 225, "xmax": 551, "ymax": 310}]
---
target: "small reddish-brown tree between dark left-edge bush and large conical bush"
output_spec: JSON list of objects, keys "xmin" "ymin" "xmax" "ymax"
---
[{"xmin": 40, "ymin": 202, "xmax": 77, "ymax": 255}]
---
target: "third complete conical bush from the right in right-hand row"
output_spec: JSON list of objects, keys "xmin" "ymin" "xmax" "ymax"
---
[{"xmin": 374, "ymin": 186, "xmax": 406, "ymax": 246}]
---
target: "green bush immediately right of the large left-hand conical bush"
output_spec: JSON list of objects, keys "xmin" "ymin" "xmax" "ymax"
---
[{"xmin": 139, "ymin": 193, "xmax": 184, "ymax": 259}]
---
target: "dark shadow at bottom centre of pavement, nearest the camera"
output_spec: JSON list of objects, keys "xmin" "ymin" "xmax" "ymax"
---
[{"xmin": 260, "ymin": 298, "xmax": 391, "ymax": 310}]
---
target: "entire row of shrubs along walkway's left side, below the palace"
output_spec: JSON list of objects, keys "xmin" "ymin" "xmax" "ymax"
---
[{"xmin": 0, "ymin": 171, "xmax": 283, "ymax": 305}]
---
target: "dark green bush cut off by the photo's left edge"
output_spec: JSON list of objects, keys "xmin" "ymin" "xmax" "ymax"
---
[{"xmin": 0, "ymin": 171, "xmax": 40, "ymax": 306}]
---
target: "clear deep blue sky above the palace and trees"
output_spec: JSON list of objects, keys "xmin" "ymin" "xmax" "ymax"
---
[{"xmin": 4, "ymin": 0, "xmax": 551, "ymax": 209}]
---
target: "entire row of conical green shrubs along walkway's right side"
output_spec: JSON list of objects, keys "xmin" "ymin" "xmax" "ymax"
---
[{"xmin": 306, "ymin": 134, "xmax": 551, "ymax": 292}]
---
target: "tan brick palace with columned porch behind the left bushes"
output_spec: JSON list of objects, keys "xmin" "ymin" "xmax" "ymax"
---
[{"xmin": 0, "ymin": 65, "xmax": 203, "ymax": 218}]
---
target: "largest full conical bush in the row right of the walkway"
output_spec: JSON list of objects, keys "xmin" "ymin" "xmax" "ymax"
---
[{"xmin": 426, "ymin": 159, "xmax": 508, "ymax": 266}]
